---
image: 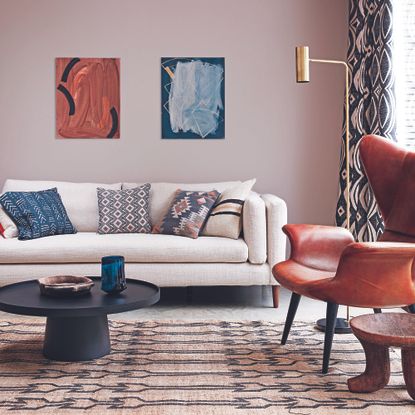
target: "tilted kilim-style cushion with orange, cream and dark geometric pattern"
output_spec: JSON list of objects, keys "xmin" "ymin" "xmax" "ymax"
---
[{"xmin": 153, "ymin": 189, "xmax": 220, "ymax": 239}]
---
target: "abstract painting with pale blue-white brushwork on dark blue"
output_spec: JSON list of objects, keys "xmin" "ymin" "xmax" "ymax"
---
[{"xmin": 161, "ymin": 58, "xmax": 225, "ymax": 139}]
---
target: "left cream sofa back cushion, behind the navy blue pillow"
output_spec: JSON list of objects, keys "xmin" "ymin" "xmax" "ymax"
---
[{"xmin": 3, "ymin": 179, "xmax": 121, "ymax": 232}]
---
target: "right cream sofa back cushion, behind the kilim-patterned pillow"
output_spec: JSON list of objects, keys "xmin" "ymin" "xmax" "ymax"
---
[{"xmin": 122, "ymin": 181, "xmax": 241, "ymax": 223}]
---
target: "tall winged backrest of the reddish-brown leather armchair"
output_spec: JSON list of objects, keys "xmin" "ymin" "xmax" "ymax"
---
[{"xmin": 359, "ymin": 135, "xmax": 415, "ymax": 243}]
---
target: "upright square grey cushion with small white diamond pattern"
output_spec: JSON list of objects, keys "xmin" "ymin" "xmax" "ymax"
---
[{"xmin": 97, "ymin": 183, "xmax": 151, "ymax": 234}]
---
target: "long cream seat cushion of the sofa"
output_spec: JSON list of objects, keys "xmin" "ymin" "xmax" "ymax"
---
[{"xmin": 0, "ymin": 232, "xmax": 248, "ymax": 264}]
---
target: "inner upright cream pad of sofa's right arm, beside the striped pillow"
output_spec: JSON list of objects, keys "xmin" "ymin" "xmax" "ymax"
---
[{"xmin": 242, "ymin": 192, "xmax": 267, "ymax": 264}]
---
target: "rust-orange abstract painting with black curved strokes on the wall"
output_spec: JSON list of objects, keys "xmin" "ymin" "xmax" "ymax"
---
[{"xmin": 55, "ymin": 58, "xmax": 120, "ymax": 139}]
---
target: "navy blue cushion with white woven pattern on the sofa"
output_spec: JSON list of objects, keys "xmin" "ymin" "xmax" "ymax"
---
[{"xmin": 0, "ymin": 188, "xmax": 76, "ymax": 240}]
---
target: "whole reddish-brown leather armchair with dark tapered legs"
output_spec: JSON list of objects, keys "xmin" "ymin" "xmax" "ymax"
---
[{"xmin": 273, "ymin": 135, "xmax": 415, "ymax": 373}]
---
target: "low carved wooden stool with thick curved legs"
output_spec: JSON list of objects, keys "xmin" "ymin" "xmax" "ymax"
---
[{"xmin": 347, "ymin": 313, "xmax": 415, "ymax": 399}]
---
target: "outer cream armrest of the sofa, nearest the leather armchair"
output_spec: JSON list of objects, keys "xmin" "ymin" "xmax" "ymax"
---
[{"xmin": 261, "ymin": 194, "xmax": 287, "ymax": 268}]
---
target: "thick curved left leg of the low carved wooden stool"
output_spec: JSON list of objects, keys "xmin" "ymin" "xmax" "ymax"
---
[{"xmin": 347, "ymin": 339, "xmax": 392, "ymax": 393}]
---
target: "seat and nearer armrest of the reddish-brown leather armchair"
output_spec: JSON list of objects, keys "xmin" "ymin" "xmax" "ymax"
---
[{"xmin": 273, "ymin": 242, "xmax": 415, "ymax": 308}]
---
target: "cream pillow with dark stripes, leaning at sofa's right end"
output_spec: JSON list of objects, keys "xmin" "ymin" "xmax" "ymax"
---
[{"xmin": 203, "ymin": 179, "xmax": 256, "ymax": 239}]
